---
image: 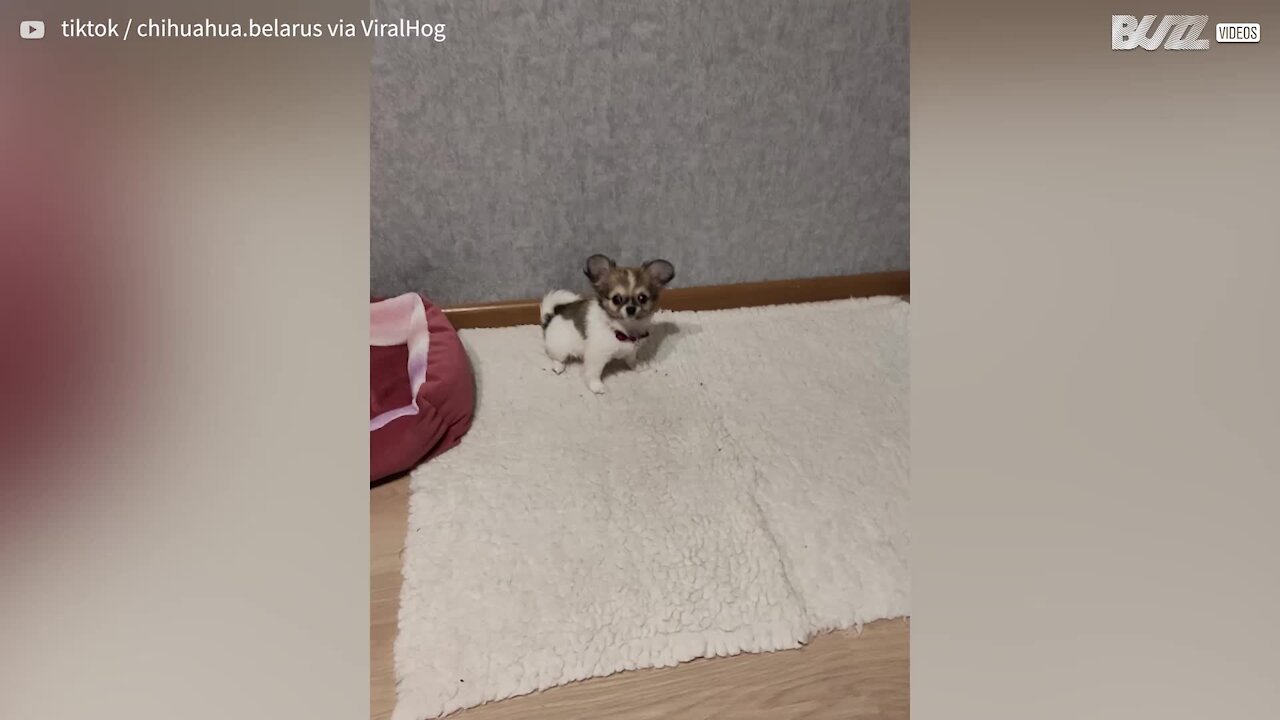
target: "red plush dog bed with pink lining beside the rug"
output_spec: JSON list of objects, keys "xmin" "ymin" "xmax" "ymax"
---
[{"xmin": 369, "ymin": 293, "xmax": 475, "ymax": 483}]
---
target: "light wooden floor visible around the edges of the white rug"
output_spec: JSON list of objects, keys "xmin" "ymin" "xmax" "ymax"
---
[{"xmin": 369, "ymin": 479, "xmax": 910, "ymax": 720}]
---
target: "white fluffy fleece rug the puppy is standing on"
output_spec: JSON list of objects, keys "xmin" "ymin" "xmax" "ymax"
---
[{"xmin": 393, "ymin": 299, "xmax": 910, "ymax": 720}]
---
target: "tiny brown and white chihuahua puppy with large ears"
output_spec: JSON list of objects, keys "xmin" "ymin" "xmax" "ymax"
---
[{"xmin": 541, "ymin": 255, "xmax": 676, "ymax": 395}]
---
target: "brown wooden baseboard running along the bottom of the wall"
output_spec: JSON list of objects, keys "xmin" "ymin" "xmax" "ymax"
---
[{"xmin": 444, "ymin": 270, "xmax": 911, "ymax": 329}]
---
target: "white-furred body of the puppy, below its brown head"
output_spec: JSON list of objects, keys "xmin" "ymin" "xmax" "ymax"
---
[{"xmin": 541, "ymin": 290, "xmax": 649, "ymax": 395}]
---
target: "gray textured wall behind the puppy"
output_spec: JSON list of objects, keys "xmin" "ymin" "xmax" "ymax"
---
[{"xmin": 371, "ymin": 0, "xmax": 909, "ymax": 305}]
